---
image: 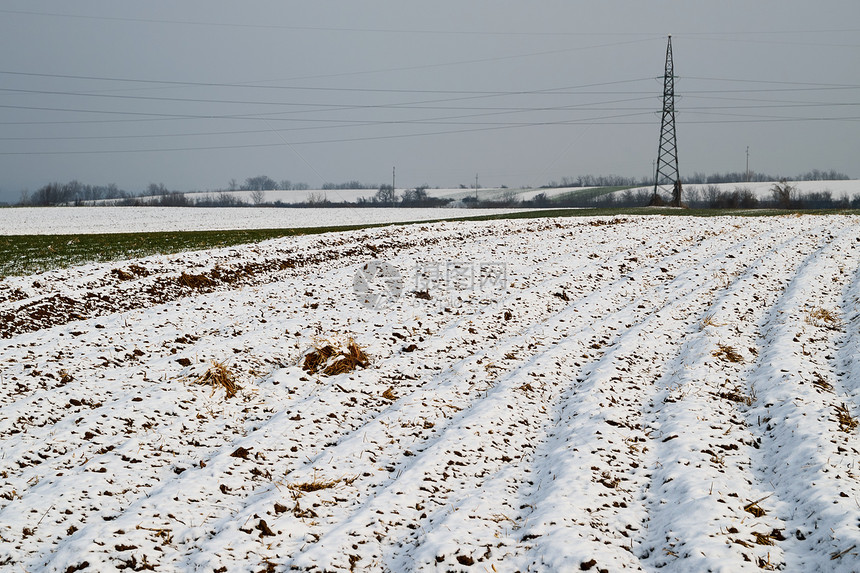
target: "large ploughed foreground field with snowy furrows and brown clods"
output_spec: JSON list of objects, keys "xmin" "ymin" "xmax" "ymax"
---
[{"xmin": 0, "ymin": 209, "xmax": 860, "ymax": 572}]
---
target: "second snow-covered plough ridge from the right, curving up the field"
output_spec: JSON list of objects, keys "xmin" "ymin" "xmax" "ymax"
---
[{"xmin": 635, "ymin": 218, "xmax": 848, "ymax": 571}]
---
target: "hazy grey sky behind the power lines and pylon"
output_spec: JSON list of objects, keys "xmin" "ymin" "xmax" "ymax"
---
[{"xmin": 0, "ymin": 0, "xmax": 860, "ymax": 201}]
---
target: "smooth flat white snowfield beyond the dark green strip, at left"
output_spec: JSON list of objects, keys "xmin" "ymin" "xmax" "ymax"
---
[{"xmin": 0, "ymin": 207, "xmax": 536, "ymax": 235}]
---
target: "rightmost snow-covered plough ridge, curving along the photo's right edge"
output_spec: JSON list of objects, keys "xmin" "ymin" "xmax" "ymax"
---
[{"xmin": 747, "ymin": 219, "xmax": 860, "ymax": 570}]
